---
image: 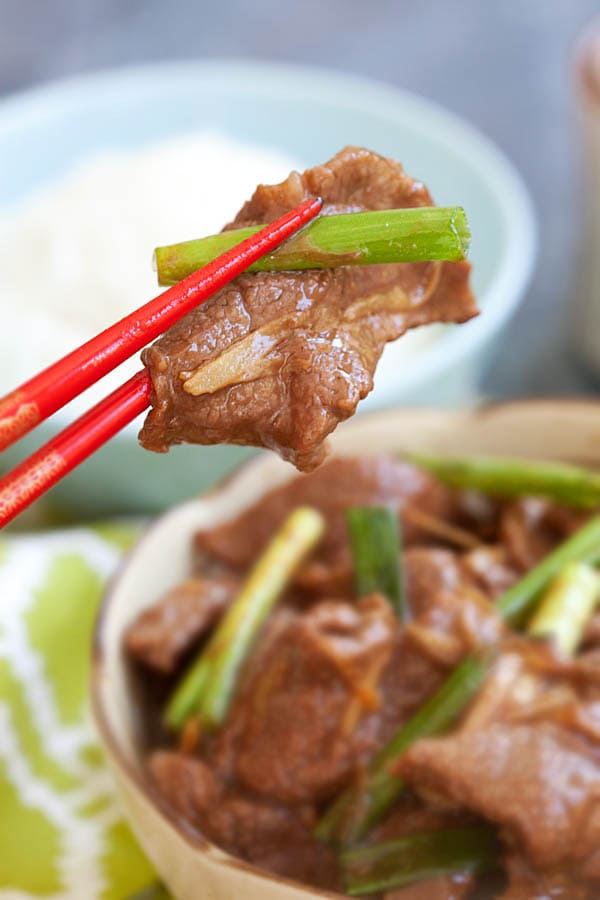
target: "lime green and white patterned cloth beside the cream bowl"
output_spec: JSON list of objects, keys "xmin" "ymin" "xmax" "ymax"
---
[{"xmin": 0, "ymin": 525, "xmax": 159, "ymax": 900}]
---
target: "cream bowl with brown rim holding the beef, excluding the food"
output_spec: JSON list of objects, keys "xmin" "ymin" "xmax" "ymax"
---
[{"xmin": 92, "ymin": 400, "xmax": 600, "ymax": 900}]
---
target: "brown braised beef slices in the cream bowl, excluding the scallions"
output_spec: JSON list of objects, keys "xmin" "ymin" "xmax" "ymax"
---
[{"xmin": 126, "ymin": 458, "xmax": 600, "ymax": 900}]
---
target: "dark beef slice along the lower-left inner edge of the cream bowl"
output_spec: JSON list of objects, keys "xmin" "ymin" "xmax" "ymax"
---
[{"xmin": 149, "ymin": 752, "xmax": 339, "ymax": 890}]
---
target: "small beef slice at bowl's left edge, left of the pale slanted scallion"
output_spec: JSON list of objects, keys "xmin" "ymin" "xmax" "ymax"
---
[{"xmin": 125, "ymin": 575, "xmax": 239, "ymax": 673}]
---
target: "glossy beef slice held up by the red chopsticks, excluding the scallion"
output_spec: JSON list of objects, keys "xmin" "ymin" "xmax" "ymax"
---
[{"xmin": 140, "ymin": 147, "xmax": 477, "ymax": 470}]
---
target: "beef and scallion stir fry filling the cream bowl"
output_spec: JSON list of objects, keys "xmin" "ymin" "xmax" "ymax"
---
[{"xmin": 126, "ymin": 457, "xmax": 600, "ymax": 900}]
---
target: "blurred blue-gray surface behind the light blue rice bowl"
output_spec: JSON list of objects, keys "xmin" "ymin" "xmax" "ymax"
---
[{"xmin": 0, "ymin": 0, "xmax": 600, "ymax": 394}]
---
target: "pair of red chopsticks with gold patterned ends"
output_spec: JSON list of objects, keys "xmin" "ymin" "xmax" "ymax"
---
[{"xmin": 0, "ymin": 199, "xmax": 322, "ymax": 528}]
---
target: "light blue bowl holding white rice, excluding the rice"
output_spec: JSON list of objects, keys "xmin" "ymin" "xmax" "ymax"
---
[{"xmin": 0, "ymin": 62, "xmax": 535, "ymax": 516}]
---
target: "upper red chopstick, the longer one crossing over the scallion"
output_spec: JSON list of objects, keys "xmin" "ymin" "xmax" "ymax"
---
[{"xmin": 0, "ymin": 199, "xmax": 322, "ymax": 451}]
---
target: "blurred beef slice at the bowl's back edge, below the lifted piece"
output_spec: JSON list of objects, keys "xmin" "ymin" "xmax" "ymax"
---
[{"xmin": 196, "ymin": 456, "xmax": 454, "ymax": 596}]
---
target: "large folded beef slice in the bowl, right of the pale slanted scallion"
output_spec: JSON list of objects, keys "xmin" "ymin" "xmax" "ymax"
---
[{"xmin": 211, "ymin": 595, "xmax": 398, "ymax": 805}]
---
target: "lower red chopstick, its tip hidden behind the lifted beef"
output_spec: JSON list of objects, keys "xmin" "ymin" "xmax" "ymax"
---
[{"xmin": 0, "ymin": 369, "xmax": 152, "ymax": 528}]
